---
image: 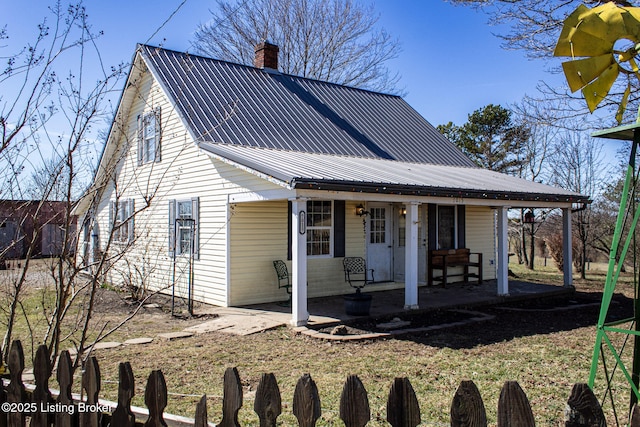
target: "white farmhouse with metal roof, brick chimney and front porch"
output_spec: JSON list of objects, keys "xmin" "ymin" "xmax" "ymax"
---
[{"xmin": 72, "ymin": 43, "xmax": 588, "ymax": 325}]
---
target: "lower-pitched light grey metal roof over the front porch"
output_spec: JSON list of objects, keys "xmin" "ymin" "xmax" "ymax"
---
[{"xmin": 199, "ymin": 142, "xmax": 589, "ymax": 203}]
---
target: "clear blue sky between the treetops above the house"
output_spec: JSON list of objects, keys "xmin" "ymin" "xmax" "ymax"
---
[{"xmin": 0, "ymin": 0, "xmax": 563, "ymax": 125}]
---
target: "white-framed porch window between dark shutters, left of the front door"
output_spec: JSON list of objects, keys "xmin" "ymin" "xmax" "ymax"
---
[{"xmin": 307, "ymin": 200, "xmax": 333, "ymax": 256}]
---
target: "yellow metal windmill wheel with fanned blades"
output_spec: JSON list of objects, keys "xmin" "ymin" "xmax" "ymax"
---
[{"xmin": 554, "ymin": 2, "xmax": 640, "ymax": 121}]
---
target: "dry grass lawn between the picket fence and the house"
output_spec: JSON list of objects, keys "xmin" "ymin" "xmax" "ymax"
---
[{"xmin": 2, "ymin": 263, "xmax": 633, "ymax": 426}]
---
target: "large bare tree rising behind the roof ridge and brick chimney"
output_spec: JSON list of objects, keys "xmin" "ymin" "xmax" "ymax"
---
[{"xmin": 192, "ymin": 0, "xmax": 400, "ymax": 92}]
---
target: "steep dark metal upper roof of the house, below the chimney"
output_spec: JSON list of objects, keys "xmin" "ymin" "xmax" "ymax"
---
[{"xmin": 139, "ymin": 45, "xmax": 476, "ymax": 167}]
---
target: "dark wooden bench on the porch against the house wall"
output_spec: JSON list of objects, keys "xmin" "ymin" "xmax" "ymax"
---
[{"xmin": 428, "ymin": 248, "xmax": 482, "ymax": 286}]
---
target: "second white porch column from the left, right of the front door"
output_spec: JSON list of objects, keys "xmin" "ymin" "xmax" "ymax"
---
[{"xmin": 404, "ymin": 202, "xmax": 420, "ymax": 310}]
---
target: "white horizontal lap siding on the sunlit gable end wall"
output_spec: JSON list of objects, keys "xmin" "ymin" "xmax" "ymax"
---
[{"xmin": 98, "ymin": 73, "xmax": 280, "ymax": 306}]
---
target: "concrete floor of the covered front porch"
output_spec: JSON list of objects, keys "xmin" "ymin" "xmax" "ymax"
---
[{"xmin": 241, "ymin": 280, "xmax": 573, "ymax": 326}]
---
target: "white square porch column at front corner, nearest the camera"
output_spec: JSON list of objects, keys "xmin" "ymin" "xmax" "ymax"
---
[{"xmin": 291, "ymin": 199, "xmax": 309, "ymax": 326}]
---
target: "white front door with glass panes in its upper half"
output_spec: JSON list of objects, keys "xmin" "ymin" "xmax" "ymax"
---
[{"xmin": 367, "ymin": 203, "xmax": 393, "ymax": 282}]
